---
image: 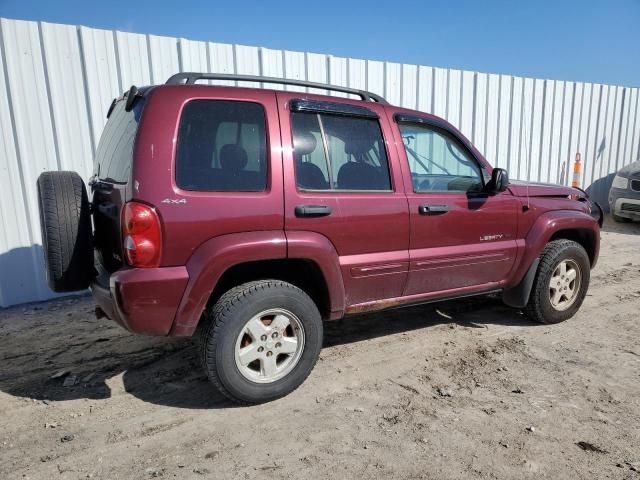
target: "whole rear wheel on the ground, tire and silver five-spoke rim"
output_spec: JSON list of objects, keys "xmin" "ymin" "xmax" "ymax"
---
[{"xmin": 200, "ymin": 280, "xmax": 322, "ymax": 404}]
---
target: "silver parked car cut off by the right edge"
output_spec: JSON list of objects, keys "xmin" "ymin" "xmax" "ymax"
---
[{"xmin": 609, "ymin": 160, "xmax": 640, "ymax": 222}]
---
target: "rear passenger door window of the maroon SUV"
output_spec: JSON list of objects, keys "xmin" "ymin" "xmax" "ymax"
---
[{"xmin": 292, "ymin": 112, "xmax": 391, "ymax": 191}]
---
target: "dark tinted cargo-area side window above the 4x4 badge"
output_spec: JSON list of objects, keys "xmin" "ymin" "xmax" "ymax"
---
[{"xmin": 176, "ymin": 100, "xmax": 267, "ymax": 192}]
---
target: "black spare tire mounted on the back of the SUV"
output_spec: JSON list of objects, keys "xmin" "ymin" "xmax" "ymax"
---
[{"xmin": 37, "ymin": 172, "xmax": 94, "ymax": 292}]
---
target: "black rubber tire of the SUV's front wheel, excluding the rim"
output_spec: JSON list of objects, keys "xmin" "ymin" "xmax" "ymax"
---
[{"xmin": 525, "ymin": 239, "xmax": 591, "ymax": 324}]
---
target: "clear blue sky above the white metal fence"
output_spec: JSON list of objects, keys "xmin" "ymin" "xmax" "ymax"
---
[{"xmin": 0, "ymin": 0, "xmax": 640, "ymax": 86}]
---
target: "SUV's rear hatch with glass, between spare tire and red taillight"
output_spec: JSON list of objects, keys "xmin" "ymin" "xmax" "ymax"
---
[{"xmin": 89, "ymin": 98, "xmax": 144, "ymax": 274}]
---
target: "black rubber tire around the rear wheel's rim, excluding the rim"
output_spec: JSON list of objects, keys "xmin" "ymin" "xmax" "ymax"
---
[{"xmin": 199, "ymin": 280, "xmax": 323, "ymax": 404}]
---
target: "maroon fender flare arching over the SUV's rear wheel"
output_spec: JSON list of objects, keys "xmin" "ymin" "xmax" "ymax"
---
[{"xmin": 170, "ymin": 230, "xmax": 344, "ymax": 336}]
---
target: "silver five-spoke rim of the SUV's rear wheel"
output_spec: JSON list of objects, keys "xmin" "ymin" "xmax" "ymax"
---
[{"xmin": 235, "ymin": 308, "xmax": 304, "ymax": 383}]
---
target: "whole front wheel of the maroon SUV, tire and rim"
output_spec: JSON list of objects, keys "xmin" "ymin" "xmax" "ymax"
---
[{"xmin": 525, "ymin": 239, "xmax": 591, "ymax": 324}]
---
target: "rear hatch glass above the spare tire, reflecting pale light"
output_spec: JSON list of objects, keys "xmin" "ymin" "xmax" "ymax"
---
[{"xmin": 93, "ymin": 99, "xmax": 144, "ymax": 183}]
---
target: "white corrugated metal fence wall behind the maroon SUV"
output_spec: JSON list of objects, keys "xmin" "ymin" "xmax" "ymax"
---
[{"xmin": 0, "ymin": 19, "xmax": 640, "ymax": 306}]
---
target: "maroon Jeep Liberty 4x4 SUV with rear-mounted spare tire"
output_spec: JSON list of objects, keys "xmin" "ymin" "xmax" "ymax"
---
[{"xmin": 38, "ymin": 73, "xmax": 602, "ymax": 403}]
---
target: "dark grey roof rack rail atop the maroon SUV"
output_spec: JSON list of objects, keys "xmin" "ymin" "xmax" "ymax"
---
[{"xmin": 166, "ymin": 72, "xmax": 389, "ymax": 105}]
